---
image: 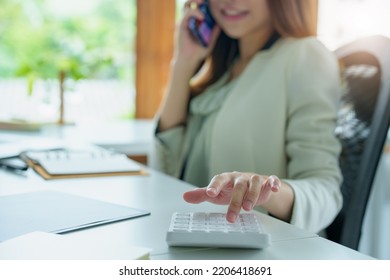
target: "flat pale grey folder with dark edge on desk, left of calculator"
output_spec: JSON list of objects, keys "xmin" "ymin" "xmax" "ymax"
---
[{"xmin": 0, "ymin": 191, "xmax": 150, "ymax": 242}]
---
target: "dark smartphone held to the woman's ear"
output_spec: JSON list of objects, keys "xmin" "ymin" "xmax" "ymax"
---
[{"xmin": 188, "ymin": 0, "xmax": 215, "ymax": 47}]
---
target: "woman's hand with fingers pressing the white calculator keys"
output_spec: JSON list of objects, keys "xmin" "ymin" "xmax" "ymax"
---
[{"xmin": 183, "ymin": 172, "xmax": 282, "ymax": 223}]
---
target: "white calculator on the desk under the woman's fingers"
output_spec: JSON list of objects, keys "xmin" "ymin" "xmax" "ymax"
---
[{"xmin": 166, "ymin": 212, "xmax": 271, "ymax": 249}]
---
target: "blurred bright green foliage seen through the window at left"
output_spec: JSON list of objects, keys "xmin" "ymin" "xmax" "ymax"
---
[{"xmin": 0, "ymin": 0, "xmax": 136, "ymax": 93}]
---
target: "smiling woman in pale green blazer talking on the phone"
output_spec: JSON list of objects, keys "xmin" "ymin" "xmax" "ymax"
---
[{"xmin": 151, "ymin": 0, "xmax": 342, "ymax": 232}]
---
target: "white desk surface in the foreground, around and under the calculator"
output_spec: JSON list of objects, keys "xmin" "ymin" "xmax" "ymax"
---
[{"xmin": 0, "ymin": 166, "xmax": 370, "ymax": 259}]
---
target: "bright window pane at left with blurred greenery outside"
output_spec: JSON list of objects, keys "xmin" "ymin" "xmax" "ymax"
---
[{"xmin": 0, "ymin": 0, "xmax": 136, "ymax": 122}]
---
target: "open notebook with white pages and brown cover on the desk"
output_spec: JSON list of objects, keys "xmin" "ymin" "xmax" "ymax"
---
[{"xmin": 21, "ymin": 149, "xmax": 146, "ymax": 180}]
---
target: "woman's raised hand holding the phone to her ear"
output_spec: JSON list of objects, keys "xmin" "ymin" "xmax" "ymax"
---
[{"xmin": 175, "ymin": 0, "xmax": 220, "ymax": 66}]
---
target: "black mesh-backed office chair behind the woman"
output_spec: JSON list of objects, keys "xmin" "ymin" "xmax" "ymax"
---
[{"xmin": 326, "ymin": 36, "xmax": 390, "ymax": 250}]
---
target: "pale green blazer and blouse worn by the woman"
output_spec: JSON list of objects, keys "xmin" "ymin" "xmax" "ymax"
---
[{"xmin": 152, "ymin": 37, "xmax": 342, "ymax": 232}]
